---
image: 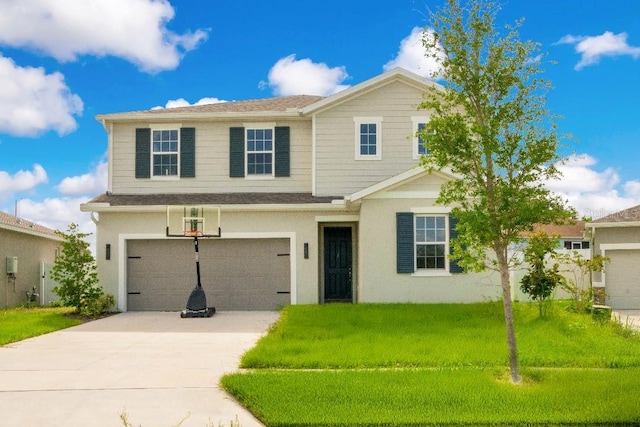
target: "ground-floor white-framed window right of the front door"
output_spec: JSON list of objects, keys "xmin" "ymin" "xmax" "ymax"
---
[{"xmin": 415, "ymin": 215, "xmax": 448, "ymax": 270}]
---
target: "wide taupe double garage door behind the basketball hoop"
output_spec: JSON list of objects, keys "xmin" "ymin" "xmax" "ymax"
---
[{"xmin": 127, "ymin": 239, "xmax": 291, "ymax": 311}]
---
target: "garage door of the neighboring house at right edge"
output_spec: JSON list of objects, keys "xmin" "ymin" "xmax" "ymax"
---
[{"xmin": 605, "ymin": 250, "xmax": 640, "ymax": 310}]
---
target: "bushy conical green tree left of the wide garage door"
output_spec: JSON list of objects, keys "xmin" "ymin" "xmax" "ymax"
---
[{"xmin": 50, "ymin": 223, "xmax": 108, "ymax": 315}]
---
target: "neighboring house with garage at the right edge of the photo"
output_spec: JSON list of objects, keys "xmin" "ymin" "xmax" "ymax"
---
[{"xmin": 587, "ymin": 206, "xmax": 640, "ymax": 310}]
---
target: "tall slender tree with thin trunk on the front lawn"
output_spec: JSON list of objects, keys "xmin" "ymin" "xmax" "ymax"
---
[{"xmin": 420, "ymin": 0, "xmax": 575, "ymax": 383}]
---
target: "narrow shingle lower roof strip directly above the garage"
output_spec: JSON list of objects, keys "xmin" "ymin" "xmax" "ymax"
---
[{"xmin": 88, "ymin": 193, "xmax": 342, "ymax": 206}]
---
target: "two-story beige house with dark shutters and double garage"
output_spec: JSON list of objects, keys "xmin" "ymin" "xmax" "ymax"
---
[{"xmin": 81, "ymin": 69, "xmax": 501, "ymax": 310}]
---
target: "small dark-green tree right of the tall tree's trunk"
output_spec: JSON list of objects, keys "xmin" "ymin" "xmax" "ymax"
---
[{"xmin": 520, "ymin": 231, "xmax": 565, "ymax": 316}]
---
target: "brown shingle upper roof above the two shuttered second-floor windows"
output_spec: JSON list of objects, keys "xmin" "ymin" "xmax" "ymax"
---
[{"xmin": 148, "ymin": 95, "xmax": 324, "ymax": 113}]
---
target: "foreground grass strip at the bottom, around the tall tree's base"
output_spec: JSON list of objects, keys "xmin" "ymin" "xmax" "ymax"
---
[{"xmin": 222, "ymin": 368, "xmax": 640, "ymax": 426}]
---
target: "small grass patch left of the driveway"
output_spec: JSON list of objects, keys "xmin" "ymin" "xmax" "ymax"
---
[{"xmin": 0, "ymin": 307, "xmax": 82, "ymax": 346}]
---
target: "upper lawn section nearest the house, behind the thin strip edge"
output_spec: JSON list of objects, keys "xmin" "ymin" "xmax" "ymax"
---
[{"xmin": 241, "ymin": 303, "xmax": 640, "ymax": 369}]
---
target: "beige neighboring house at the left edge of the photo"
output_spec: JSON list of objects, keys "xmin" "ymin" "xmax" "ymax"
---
[{"xmin": 0, "ymin": 212, "xmax": 62, "ymax": 307}]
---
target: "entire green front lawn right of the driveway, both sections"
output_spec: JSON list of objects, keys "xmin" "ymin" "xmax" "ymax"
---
[{"xmin": 222, "ymin": 303, "xmax": 640, "ymax": 426}]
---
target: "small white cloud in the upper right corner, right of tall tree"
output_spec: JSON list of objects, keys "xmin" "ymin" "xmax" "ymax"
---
[{"xmin": 556, "ymin": 31, "xmax": 640, "ymax": 70}]
